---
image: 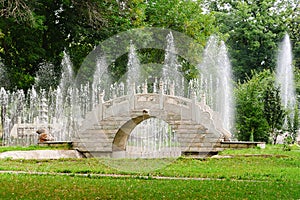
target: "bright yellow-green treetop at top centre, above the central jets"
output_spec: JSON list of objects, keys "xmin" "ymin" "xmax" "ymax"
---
[{"xmin": 146, "ymin": 0, "xmax": 218, "ymax": 46}]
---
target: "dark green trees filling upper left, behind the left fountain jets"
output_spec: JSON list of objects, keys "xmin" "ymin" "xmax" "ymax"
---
[{"xmin": 0, "ymin": 0, "xmax": 129, "ymax": 89}]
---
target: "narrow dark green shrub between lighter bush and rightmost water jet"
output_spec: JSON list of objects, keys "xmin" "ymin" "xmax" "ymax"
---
[{"xmin": 264, "ymin": 82, "xmax": 286, "ymax": 144}]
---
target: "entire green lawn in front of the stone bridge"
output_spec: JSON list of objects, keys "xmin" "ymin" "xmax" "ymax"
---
[{"xmin": 0, "ymin": 146, "xmax": 300, "ymax": 199}]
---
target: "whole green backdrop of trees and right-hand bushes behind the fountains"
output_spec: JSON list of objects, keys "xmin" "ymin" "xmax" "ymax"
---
[{"xmin": 0, "ymin": 0, "xmax": 300, "ymax": 142}]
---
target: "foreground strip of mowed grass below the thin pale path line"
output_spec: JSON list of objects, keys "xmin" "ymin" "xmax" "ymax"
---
[{"xmin": 0, "ymin": 174, "xmax": 299, "ymax": 199}]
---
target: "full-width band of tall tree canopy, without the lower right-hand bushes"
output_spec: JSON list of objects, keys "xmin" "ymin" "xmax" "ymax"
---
[{"xmin": 0, "ymin": 0, "xmax": 300, "ymax": 89}]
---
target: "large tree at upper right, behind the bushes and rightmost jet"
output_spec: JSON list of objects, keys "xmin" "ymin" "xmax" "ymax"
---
[{"xmin": 207, "ymin": 0, "xmax": 299, "ymax": 80}]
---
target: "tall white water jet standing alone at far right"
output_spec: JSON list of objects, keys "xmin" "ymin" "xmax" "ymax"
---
[{"xmin": 276, "ymin": 34, "xmax": 296, "ymax": 110}]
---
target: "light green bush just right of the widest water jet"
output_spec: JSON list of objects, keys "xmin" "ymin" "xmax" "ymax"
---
[{"xmin": 235, "ymin": 70, "xmax": 272, "ymax": 142}]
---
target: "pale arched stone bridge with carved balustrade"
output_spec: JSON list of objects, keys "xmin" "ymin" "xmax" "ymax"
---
[{"xmin": 73, "ymin": 86, "xmax": 231, "ymax": 157}]
